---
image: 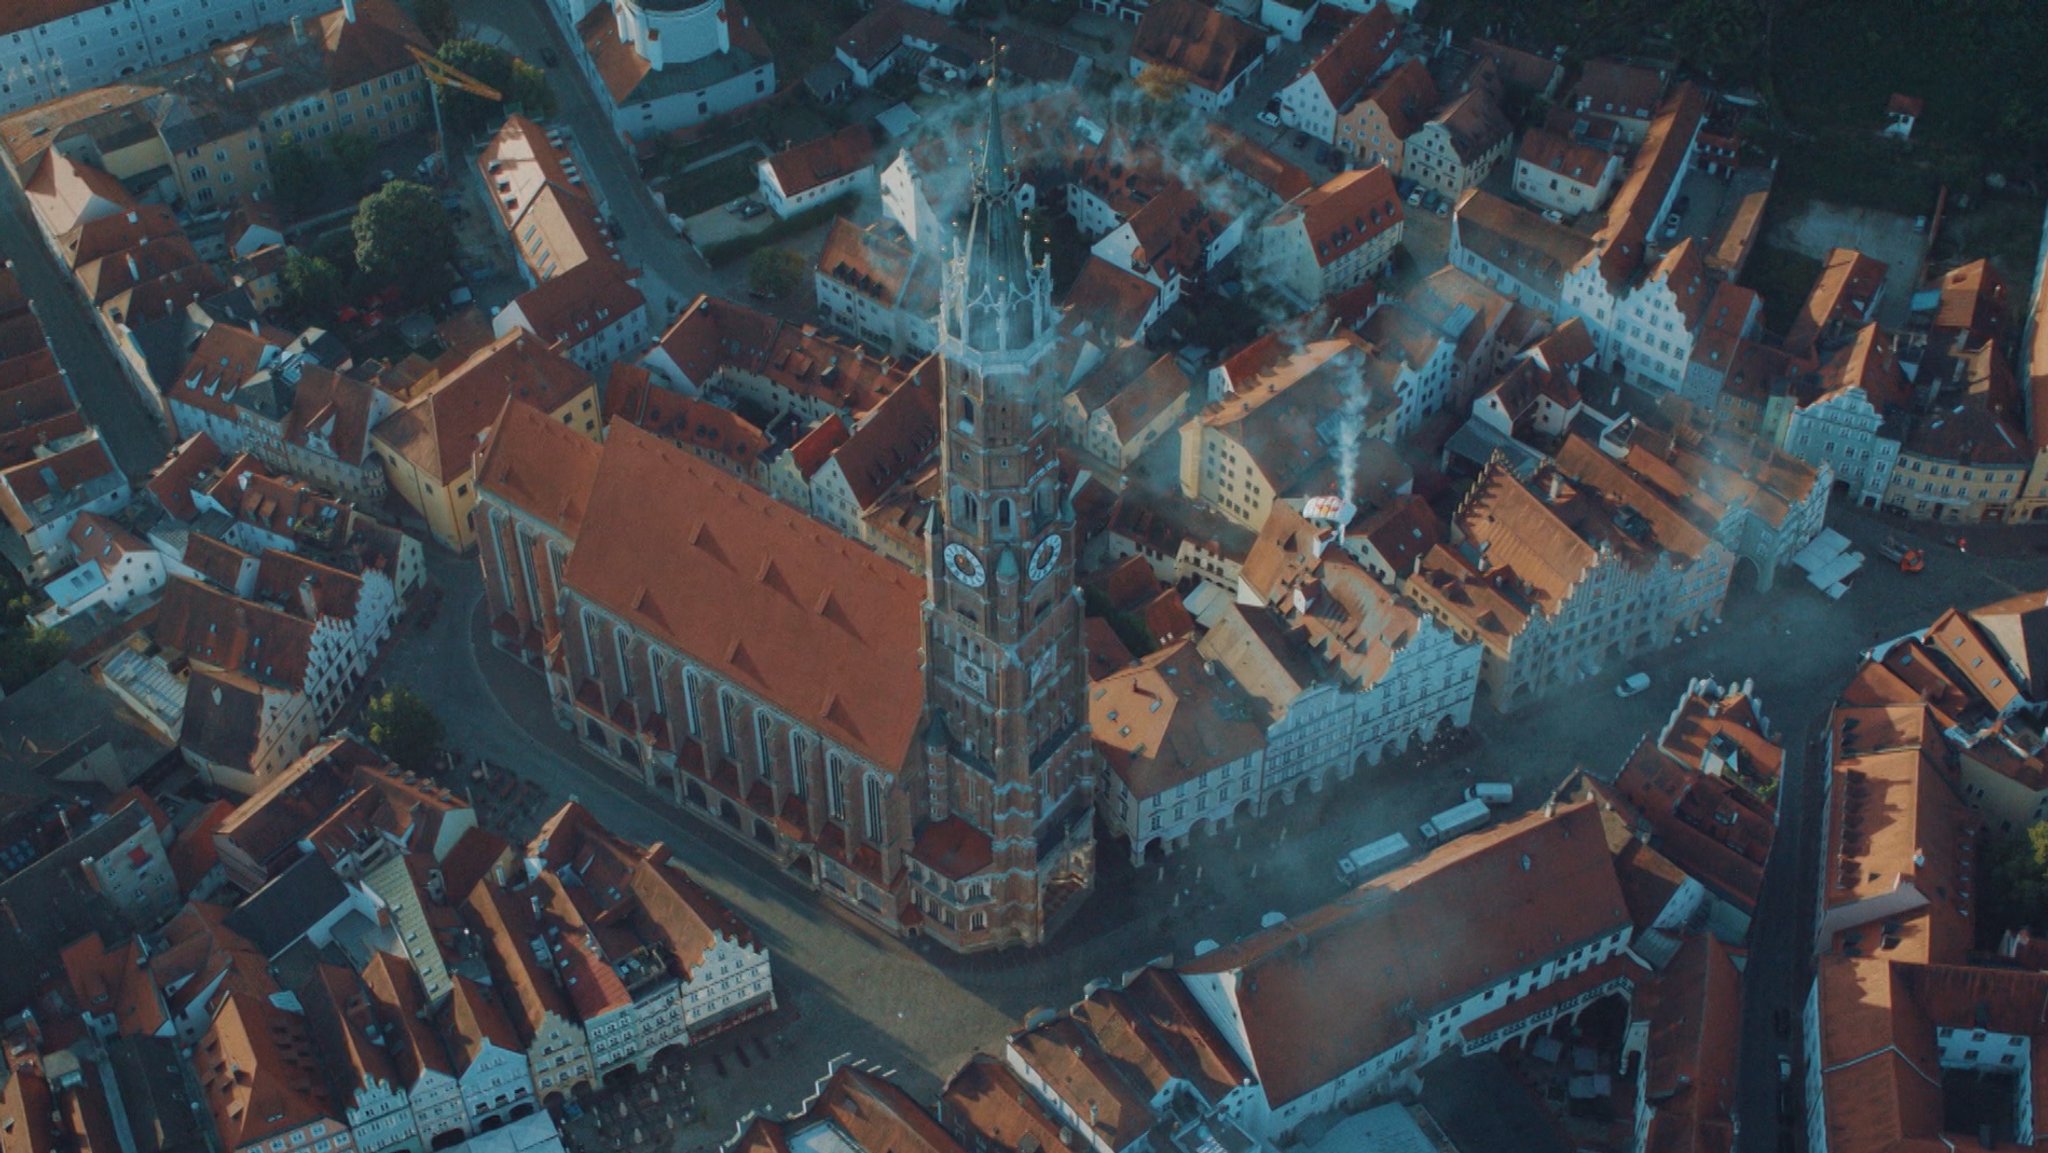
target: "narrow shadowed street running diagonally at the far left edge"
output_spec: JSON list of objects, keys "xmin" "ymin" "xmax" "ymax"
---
[{"xmin": 0, "ymin": 164, "xmax": 168, "ymax": 477}]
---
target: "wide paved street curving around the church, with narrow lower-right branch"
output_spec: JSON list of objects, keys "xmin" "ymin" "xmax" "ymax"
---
[{"xmin": 372, "ymin": 509, "xmax": 2038, "ymax": 1141}]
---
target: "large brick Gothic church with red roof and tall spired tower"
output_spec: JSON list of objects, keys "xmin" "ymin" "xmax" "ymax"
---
[{"xmin": 477, "ymin": 86, "xmax": 1096, "ymax": 952}]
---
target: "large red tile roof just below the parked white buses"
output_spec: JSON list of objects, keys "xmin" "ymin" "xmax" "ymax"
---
[{"xmin": 1180, "ymin": 803, "xmax": 1630, "ymax": 1108}]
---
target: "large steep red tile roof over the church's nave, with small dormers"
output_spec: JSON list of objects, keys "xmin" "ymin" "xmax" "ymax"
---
[{"xmin": 567, "ymin": 422, "xmax": 924, "ymax": 770}]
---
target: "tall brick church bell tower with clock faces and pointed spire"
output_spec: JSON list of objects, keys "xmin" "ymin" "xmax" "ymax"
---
[{"xmin": 922, "ymin": 68, "xmax": 1094, "ymax": 948}]
